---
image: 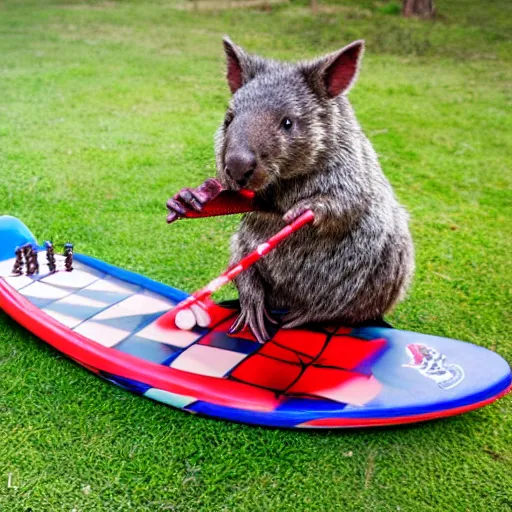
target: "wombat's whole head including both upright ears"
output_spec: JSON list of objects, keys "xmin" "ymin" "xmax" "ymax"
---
[{"xmin": 216, "ymin": 40, "xmax": 362, "ymax": 191}]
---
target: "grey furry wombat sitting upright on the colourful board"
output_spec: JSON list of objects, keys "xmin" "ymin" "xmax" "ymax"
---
[{"xmin": 171, "ymin": 37, "xmax": 414, "ymax": 342}]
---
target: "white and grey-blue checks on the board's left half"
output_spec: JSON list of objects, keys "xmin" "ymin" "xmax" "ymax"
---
[{"xmin": 0, "ymin": 251, "xmax": 196, "ymax": 363}]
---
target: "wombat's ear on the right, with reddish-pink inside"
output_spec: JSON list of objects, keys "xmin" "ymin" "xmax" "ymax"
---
[{"xmin": 303, "ymin": 40, "xmax": 364, "ymax": 98}]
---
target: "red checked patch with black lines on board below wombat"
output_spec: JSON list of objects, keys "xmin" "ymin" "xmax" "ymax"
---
[{"xmin": 199, "ymin": 319, "xmax": 386, "ymax": 406}]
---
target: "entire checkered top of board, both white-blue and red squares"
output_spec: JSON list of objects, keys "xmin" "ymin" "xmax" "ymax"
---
[{"xmin": 0, "ymin": 252, "xmax": 385, "ymax": 405}]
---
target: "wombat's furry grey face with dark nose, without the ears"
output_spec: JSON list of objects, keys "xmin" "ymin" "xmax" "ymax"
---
[{"xmin": 217, "ymin": 69, "xmax": 325, "ymax": 190}]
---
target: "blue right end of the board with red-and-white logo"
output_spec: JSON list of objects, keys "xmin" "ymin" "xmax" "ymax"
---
[{"xmin": 343, "ymin": 327, "xmax": 512, "ymax": 418}]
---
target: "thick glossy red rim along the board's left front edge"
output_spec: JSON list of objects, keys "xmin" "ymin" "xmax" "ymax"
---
[{"xmin": 0, "ymin": 278, "xmax": 280, "ymax": 411}]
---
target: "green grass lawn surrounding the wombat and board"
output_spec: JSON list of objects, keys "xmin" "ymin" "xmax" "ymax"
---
[{"xmin": 0, "ymin": 0, "xmax": 512, "ymax": 512}]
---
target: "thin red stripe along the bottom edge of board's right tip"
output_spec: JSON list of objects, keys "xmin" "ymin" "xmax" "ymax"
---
[{"xmin": 297, "ymin": 384, "xmax": 512, "ymax": 428}]
